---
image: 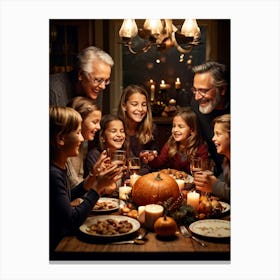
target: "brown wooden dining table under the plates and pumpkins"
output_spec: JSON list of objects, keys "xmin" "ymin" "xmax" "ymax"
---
[{"xmin": 50, "ymin": 207, "xmax": 230, "ymax": 261}]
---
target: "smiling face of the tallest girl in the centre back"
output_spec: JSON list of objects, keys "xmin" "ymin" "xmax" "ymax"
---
[{"xmin": 123, "ymin": 92, "xmax": 148, "ymax": 123}]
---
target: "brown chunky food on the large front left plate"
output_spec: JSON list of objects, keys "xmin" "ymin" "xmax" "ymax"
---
[{"xmin": 86, "ymin": 219, "xmax": 132, "ymax": 235}]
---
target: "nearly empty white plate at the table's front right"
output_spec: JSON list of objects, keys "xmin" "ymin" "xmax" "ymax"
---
[{"xmin": 189, "ymin": 219, "xmax": 230, "ymax": 238}]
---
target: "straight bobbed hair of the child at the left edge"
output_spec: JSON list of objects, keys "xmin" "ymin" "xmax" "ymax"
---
[{"xmin": 49, "ymin": 106, "xmax": 82, "ymax": 150}]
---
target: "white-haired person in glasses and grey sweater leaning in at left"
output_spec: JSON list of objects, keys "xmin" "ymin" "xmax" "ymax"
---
[{"xmin": 49, "ymin": 46, "xmax": 114, "ymax": 106}]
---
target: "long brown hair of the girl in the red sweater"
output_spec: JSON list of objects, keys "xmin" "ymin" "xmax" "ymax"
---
[{"xmin": 168, "ymin": 107, "xmax": 203, "ymax": 159}]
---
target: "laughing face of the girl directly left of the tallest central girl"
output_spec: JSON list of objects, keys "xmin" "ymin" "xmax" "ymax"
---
[{"xmin": 102, "ymin": 120, "xmax": 125, "ymax": 150}]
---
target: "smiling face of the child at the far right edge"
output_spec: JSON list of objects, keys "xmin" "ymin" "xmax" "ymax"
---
[{"xmin": 212, "ymin": 123, "xmax": 230, "ymax": 158}]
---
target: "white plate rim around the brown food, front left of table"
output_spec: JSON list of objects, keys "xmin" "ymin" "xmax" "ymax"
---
[{"xmin": 80, "ymin": 215, "xmax": 141, "ymax": 238}]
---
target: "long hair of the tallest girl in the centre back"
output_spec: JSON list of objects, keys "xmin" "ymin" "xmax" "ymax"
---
[{"xmin": 118, "ymin": 85, "xmax": 154, "ymax": 144}]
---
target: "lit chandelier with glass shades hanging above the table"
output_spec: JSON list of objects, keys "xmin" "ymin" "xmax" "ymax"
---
[{"xmin": 119, "ymin": 19, "xmax": 200, "ymax": 54}]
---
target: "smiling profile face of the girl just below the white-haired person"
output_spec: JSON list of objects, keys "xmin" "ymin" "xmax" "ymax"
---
[{"xmin": 82, "ymin": 111, "xmax": 101, "ymax": 141}]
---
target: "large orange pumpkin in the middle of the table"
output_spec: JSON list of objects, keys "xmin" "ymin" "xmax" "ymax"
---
[{"xmin": 132, "ymin": 172, "xmax": 180, "ymax": 206}]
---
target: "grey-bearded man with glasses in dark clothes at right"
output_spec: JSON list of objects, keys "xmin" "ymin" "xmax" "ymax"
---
[{"xmin": 191, "ymin": 61, "xmax": 230, "ymax": 176}]
